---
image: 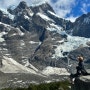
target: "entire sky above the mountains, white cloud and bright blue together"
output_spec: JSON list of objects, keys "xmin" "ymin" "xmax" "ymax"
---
[{"xmin": 0, "ymin": 0, "xmax": 90, "ymax": 21}]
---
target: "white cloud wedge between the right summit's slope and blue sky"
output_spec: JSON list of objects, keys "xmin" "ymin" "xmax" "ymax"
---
[{"xmin": 50, "ymin": 0, "xmax": 75, "ymax": 18}]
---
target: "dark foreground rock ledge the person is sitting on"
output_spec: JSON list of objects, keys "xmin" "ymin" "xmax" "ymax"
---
[{"xmin": 71, "ymin": 75, "xmax": 90, "ymax": 90}]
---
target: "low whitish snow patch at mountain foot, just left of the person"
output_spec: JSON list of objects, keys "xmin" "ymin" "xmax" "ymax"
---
[{"xmin": 42, "ymin": 66, "xmax": 70, "ymax": 76}]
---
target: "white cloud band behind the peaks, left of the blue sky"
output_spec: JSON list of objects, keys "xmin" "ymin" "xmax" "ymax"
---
[{"xmin": 0, "ymin": 0, "xmax": 75, "ymax": 18}]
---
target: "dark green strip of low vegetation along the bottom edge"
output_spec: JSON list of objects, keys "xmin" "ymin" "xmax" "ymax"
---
[{"xmin": 2, "ymin": 81, "xmax": 70, "ymax": 90}]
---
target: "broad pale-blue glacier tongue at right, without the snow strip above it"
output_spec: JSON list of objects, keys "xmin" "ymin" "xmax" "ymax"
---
[{"xmin": 53, "ymin": 35, "xmax": 90, "ymax": 57}]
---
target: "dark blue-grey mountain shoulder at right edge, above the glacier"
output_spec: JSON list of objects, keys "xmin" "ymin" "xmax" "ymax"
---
[{"xmin": 73, "ymin": 13, "xmax": 90, "ymax": 38}]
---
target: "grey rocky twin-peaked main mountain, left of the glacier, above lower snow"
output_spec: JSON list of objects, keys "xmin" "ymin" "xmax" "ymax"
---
[{"xmin": 0, "ymin": 1, "xmax": 72, "ymax": 68}]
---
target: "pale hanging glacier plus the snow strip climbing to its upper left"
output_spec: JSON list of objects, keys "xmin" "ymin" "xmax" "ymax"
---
[{"xmin": 47, "ymin": 23, "xmax": 90, "ymax": 58}]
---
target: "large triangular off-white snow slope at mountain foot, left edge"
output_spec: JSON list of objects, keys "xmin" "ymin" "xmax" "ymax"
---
[{"xmin": 0, "ymin": 56, "xmax": 36, "ymax": 74}]
